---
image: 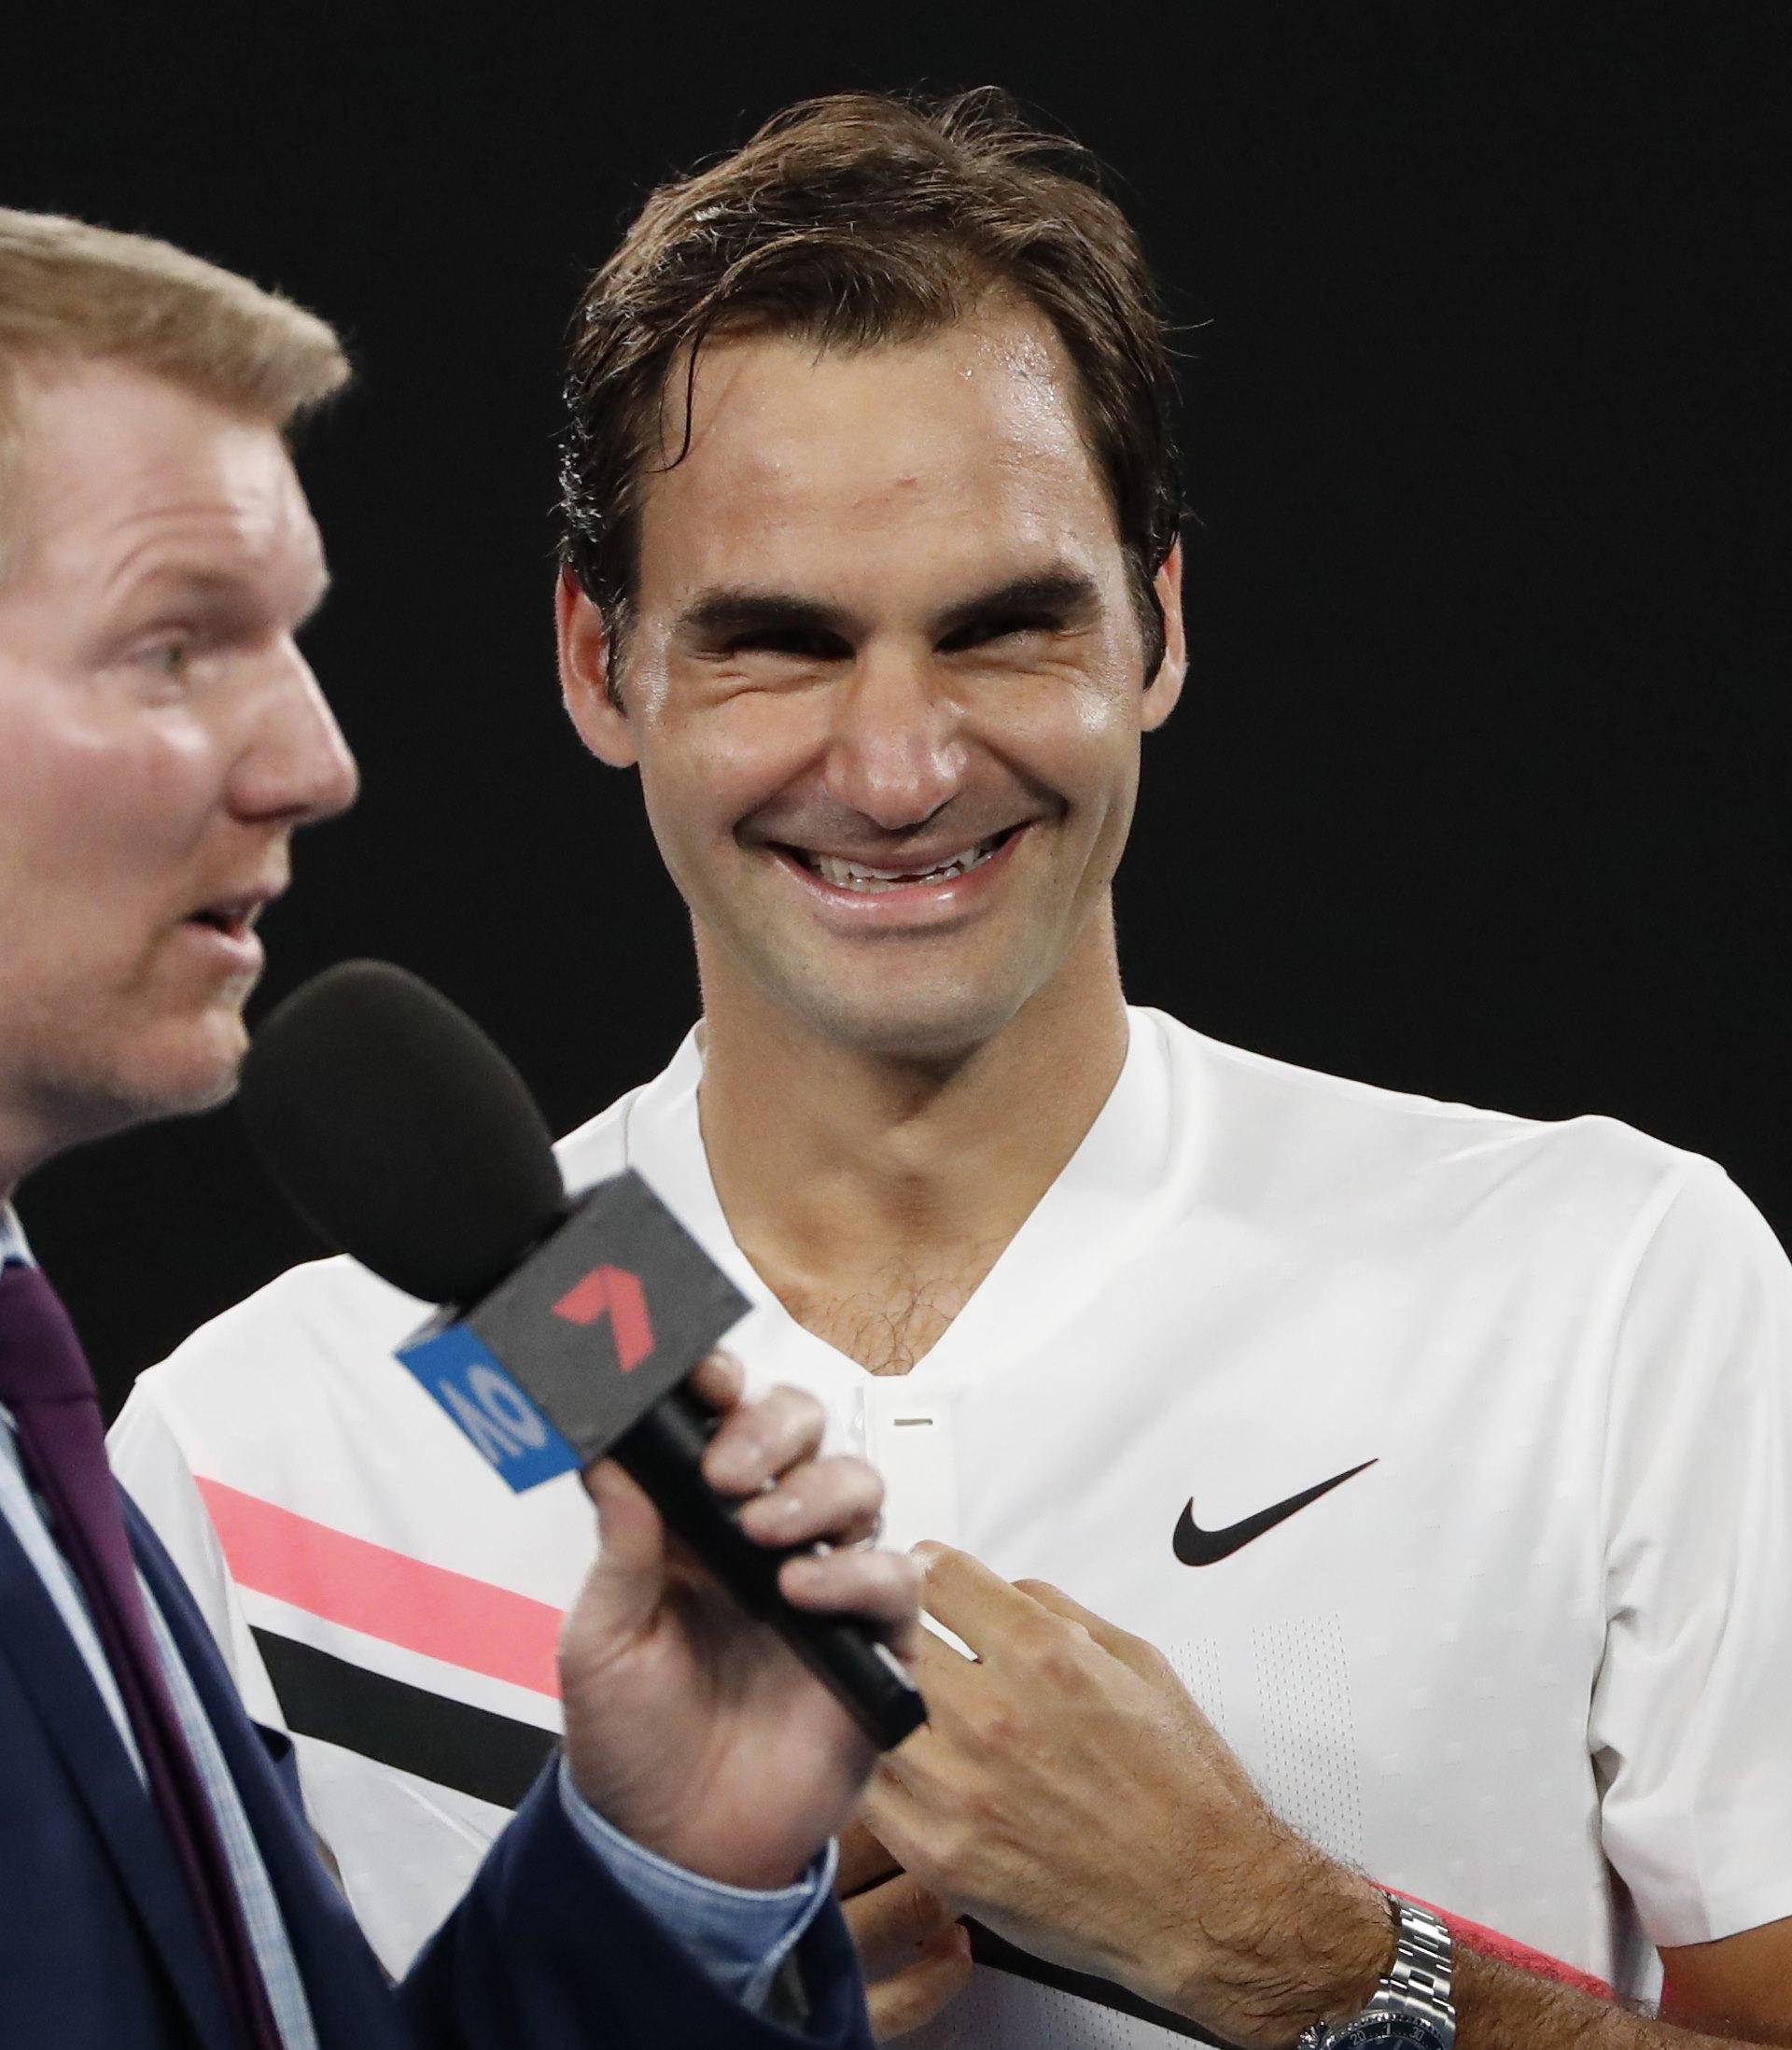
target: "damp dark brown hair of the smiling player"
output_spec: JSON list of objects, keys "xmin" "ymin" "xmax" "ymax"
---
[{"xmin": 560, "ymin": 88, "xmax": 1179, "ymax": 634}]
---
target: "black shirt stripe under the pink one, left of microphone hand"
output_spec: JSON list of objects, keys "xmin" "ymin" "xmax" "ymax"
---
[{"xmin": 252, "ymin": 1628, "xmax": 560, "ymax": 1808}]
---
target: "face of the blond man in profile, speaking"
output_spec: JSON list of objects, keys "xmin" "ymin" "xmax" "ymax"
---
[{"xmin": 0, "ymin": 363, "xmax": 355, "ymax": 1179}]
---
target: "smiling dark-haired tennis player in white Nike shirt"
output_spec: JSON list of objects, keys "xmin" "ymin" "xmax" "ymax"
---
[{"xmin": 117, "ymin": 94, "xmax": 1792, "ymax": 2050}]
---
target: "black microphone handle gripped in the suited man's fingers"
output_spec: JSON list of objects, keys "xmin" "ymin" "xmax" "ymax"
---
[{"xmin": 611, "ymin": 1388, "xmax": 927, "ymax": 1750}]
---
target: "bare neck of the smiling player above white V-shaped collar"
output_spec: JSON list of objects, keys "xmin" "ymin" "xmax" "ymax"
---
[{"xmin": 699, "ymin": 931, "xmax": 1127, "ymax": 1371}]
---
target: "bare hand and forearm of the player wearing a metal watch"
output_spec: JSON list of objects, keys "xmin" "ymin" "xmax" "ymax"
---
[{"xmin": 865, "ymin": 1548, "xmax": 1792, "ymax": 2050}]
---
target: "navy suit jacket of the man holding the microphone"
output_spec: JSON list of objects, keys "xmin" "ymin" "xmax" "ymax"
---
[{"xmin": 0, "ymin": 1500, "xmax": 872, "ymax": 2050}]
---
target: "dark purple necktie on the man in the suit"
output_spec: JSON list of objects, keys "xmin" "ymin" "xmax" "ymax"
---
[{"xmin": 0, "ymin": 1265, "xmax": 281, "ymax": 2050}]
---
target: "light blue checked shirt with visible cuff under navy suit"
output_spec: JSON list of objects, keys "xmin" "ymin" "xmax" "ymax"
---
[{"xmin": 0, "ymin": 1207, "xmax": 824, "ymax": 2025}]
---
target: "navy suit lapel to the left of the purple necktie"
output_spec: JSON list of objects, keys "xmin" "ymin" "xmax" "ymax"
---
[{"xmin": 0, "ymin": 1517, "xmax": 231, "ymax": 2050}]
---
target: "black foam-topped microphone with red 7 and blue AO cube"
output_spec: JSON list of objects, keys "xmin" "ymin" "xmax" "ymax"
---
[{"xmin": 240, "ymin": 962, "xmax": 927, "ymax": 1750}]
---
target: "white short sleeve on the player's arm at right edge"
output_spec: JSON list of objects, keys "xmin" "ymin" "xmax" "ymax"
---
[{"xmin": 1589, "ymin": 1160, "xmax": 1792, "ymax": 1945}]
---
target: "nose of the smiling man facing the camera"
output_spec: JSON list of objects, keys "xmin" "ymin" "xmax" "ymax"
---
[{"xmin": 822, "ymin": 652, "xmax": 963, "ymax": 833}]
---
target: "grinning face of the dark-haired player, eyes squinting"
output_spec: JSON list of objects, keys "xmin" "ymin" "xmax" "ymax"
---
[{"xmin": 562, "ymin": 302, "xmax": 1181, "ymax": 1060}]
